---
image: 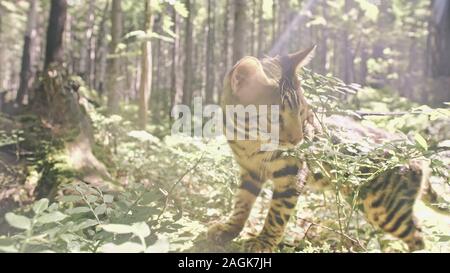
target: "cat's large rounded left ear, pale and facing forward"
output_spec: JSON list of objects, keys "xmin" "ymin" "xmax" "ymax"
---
[{"xmin": 230, "ymin": 57, "xmax": 270, "ymax": 101}]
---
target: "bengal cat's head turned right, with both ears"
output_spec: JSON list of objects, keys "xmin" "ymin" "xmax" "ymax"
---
[{"xmin": 224, "ymin": 46, "xmax": 316, "ymax": 145}]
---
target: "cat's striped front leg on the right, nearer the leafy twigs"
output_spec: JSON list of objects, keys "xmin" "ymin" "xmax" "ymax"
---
[{"xmin": 246, "ymin": 159, "xmax": 306, "ymax": 253}]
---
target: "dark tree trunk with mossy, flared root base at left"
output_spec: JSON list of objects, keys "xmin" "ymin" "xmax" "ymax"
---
[{"xmin": 33, "ymin": 0, "xmax": 111, "ymax": 198}]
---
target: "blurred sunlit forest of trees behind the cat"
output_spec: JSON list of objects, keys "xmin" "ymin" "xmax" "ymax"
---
[{"xmin": 0, "ymin": 0, "xmax": 450, "ymax": 118}]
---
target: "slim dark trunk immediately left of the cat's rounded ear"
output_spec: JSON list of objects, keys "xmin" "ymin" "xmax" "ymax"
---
[{"xmin": 206, "ymin": 0, "xmax": 216, "ymax": 104}]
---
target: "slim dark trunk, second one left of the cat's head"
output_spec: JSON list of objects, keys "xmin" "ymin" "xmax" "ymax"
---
[{"xmin": 183, "ymin": 0, "xmax": 195, "ymax": 106}]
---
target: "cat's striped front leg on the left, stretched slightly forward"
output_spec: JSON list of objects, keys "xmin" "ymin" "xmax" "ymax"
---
[{"xmin": 208, "ymin": 170, "xmax": 263, "ymax": 243}]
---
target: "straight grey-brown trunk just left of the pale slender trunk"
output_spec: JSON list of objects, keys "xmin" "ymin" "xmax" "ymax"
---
[{"xmin": 107, "ymin": 0, "xmax": 122, "ymax": 114}]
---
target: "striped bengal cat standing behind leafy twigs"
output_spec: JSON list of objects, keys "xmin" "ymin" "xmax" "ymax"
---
[{"xmin": 208, "ymin": 47, "xmax": 450, "ymax": 252}]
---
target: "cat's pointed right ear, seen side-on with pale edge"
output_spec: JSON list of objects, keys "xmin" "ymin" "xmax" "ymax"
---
[{"xmin": 281, "ymin": 45, "xmax": 317, "ymax": 77}]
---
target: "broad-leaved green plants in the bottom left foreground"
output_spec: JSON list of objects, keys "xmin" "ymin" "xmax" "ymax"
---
[{"xmin": 0, "ymin": 180, "xmax": 176, "ymax": 252}]
